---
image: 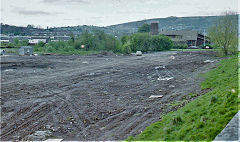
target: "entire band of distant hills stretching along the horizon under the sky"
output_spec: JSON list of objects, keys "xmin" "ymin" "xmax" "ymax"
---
[{"xmin": 1, "ymin": 16, "xmax": 238, "ymax": 36}]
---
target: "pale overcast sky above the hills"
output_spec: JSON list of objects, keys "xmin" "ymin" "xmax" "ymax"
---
[{"xmin": 0, "ymin": 0, "xmax": 240, "ymax": 28}]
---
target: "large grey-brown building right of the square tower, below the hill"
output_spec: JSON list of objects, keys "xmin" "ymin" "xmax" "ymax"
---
[{"xmin": 159, "ymin": 30, "xmax": 209, "ymax": 46}]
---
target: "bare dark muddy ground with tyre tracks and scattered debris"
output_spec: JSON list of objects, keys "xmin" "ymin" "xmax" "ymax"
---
[{"xmin": 1, "ymin": 51, "xmax": 219, "ymax": 140}]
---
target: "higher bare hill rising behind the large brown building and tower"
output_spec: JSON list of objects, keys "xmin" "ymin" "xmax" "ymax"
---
[{"xmin": 108, "ymin": 16, "xmax": 220, "ymax": 34}]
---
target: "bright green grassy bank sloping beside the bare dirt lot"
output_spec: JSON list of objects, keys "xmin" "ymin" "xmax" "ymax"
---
[{"xmin": 127, "ymin": 57, "xmax": 239, "ymax": 141}]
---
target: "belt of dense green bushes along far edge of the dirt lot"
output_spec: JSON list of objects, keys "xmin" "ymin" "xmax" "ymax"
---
[{"xmin": 35, "ymin": 31, "xmax": 173, "ymax": 54}]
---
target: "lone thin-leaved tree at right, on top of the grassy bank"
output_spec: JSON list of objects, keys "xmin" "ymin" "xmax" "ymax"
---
[{"xmin": 208, "ymin": 12, "xmax": 238, "ymax": 55}]
